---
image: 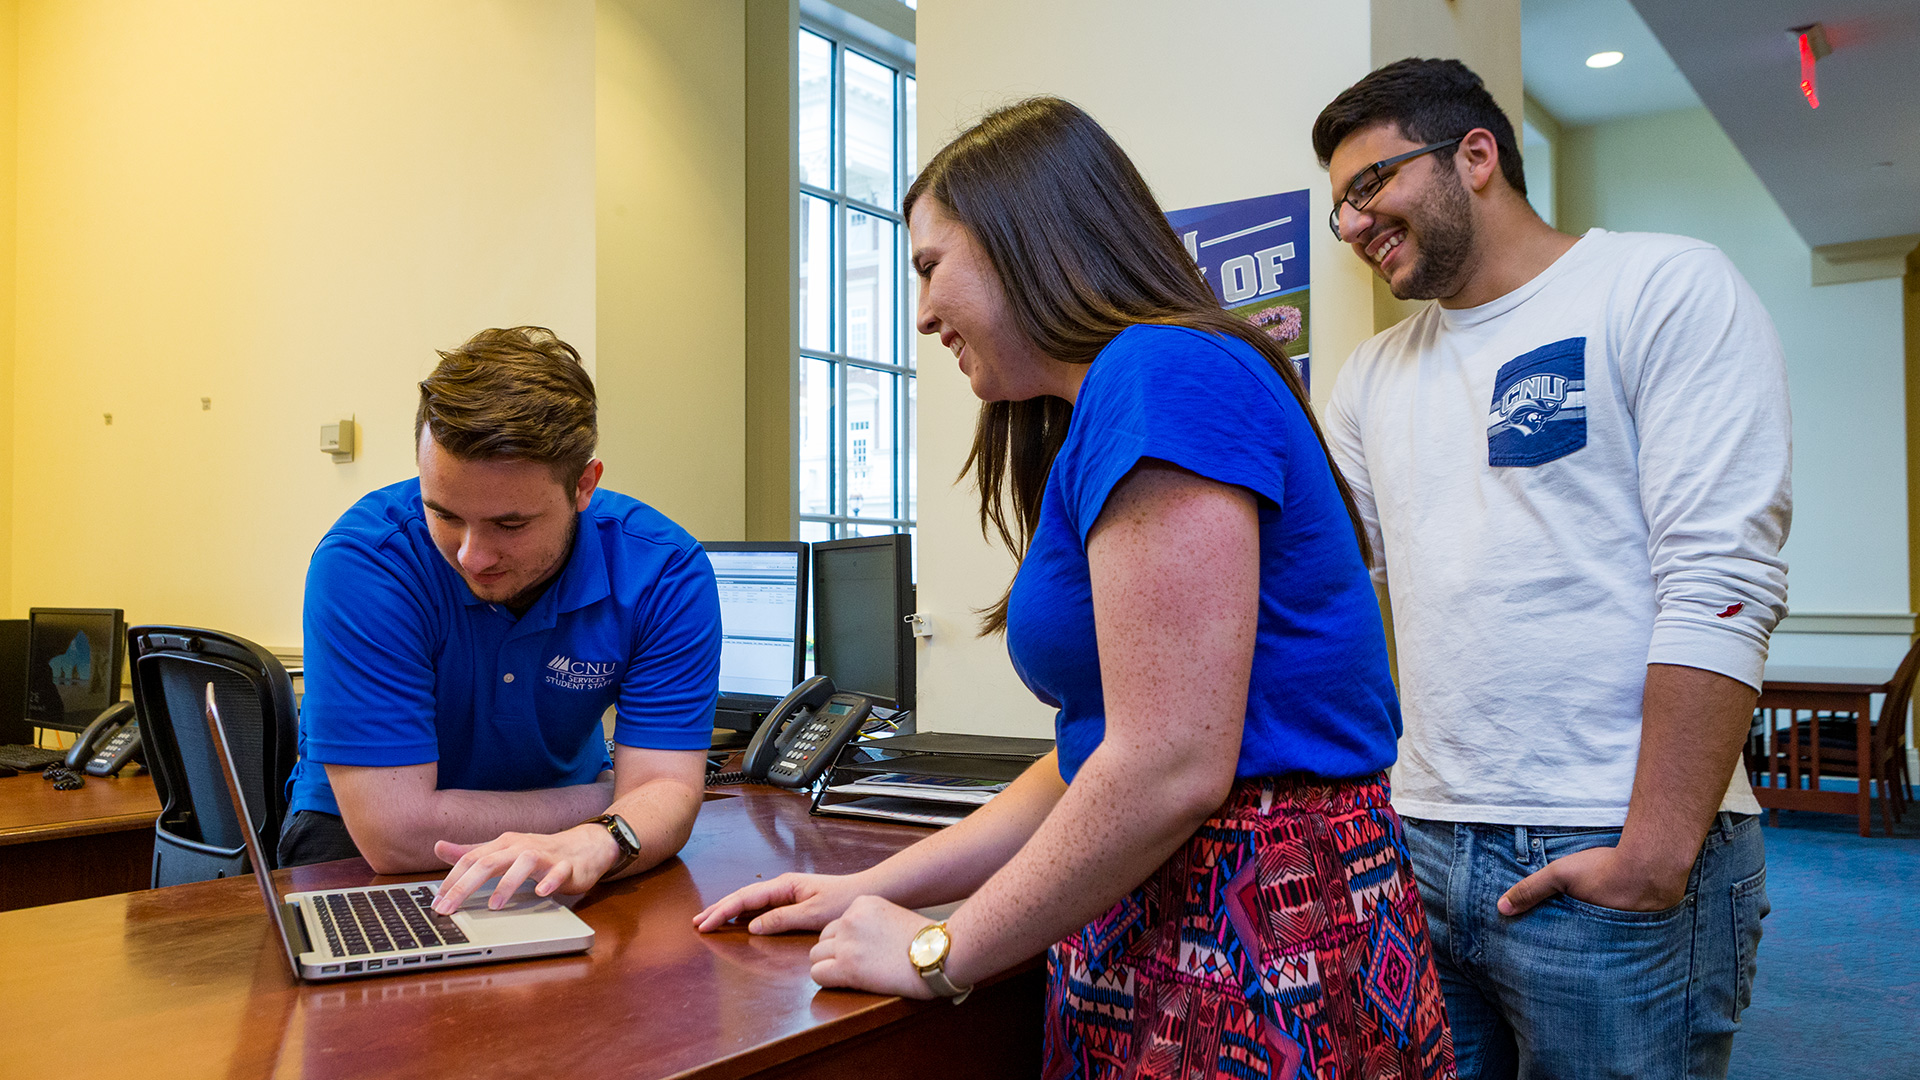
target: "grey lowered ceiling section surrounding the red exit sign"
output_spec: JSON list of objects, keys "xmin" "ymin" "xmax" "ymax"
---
[{"xmin": 1628, "ymin": 0, "xmax": 1920, "ymax": 246}]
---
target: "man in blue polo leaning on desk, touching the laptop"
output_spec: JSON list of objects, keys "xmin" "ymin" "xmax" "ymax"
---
[{"xmin": 280, "ymin": 327, "xmax": 720, "ymax": 911}]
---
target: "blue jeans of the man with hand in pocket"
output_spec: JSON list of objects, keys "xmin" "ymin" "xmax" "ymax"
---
[{"xmin": 1405, "ymin": 813, "xmax": 1766, "ymax": 1080}]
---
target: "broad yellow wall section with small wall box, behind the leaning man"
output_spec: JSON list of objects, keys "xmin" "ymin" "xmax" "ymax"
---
[{"xmin": 11, "ymin": 0, "xmax": 595, "ymax": 646}]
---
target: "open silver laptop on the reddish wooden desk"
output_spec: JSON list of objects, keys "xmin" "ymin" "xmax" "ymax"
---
[{"xmin": 207, "ymin": 682, "xmax": 593, "ymax": 980}]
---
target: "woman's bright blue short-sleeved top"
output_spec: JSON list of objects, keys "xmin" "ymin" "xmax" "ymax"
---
[{"xmin": 1006, "ymin": 325, "xmax": 1400, "ymax": 782}]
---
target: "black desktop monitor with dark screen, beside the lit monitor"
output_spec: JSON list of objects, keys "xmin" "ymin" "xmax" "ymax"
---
[{"xmin": 814, "ymin": 532, "xmax": 914, "ymax": 709}]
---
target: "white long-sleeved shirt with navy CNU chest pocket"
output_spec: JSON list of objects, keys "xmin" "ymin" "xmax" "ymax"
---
[{"xmin": 1327, "ymin": 229, "xmax": 1791, "ymax": 826}]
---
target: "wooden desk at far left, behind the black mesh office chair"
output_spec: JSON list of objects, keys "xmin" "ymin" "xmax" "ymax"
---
[{"xmin": 0, "ymin": 773, "xmax": 159, "ymax": 911}]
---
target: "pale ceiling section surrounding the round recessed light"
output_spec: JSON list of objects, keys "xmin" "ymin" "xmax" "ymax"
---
[{"xmin": 1521, "ymin": 0, "xmax": 1699, "ymax": 125}]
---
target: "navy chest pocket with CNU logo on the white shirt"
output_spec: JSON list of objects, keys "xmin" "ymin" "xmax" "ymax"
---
[{"xmin": 1486, "ymin": 338, "xmax": 1586, "ymax": 467}]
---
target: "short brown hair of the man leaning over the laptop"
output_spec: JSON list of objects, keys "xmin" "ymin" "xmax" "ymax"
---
[{"xmin": 413, "ymin": 327, "xmax": 599, "ymax": 488}]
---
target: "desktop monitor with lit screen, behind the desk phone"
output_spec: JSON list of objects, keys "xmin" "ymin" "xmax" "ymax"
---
[{"xmin": 701, "ymin": 542, "xmax": 806, "ymax": 732}]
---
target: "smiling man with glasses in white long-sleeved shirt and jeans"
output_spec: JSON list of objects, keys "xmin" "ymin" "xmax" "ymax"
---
[{"xmin": 1313, "ymin": 60, "xmax": 1791, "ymax": 1078}]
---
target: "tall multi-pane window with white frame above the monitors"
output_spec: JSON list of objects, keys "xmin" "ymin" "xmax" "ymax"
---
[{"xmin": 795, "ymin": 23, "xmax": 918, "ymax": 540}]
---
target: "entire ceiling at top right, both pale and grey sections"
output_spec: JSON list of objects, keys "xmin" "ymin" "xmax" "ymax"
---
[{"xmin": 1521, "ymin": 0, "xmax": 1920, "ymax": 248}]
